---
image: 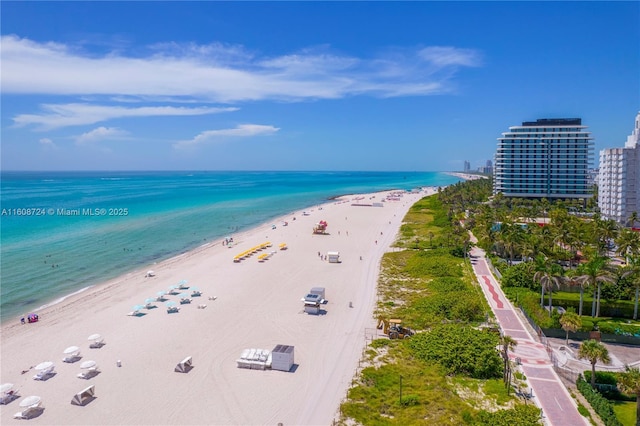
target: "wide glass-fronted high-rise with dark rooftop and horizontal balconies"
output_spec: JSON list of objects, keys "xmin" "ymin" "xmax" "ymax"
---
[{"xmin": 493, "ymin": 118, "xmax": 593, "ymax": 199}]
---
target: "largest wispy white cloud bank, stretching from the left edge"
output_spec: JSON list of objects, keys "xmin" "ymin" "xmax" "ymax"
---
[{"xmin": 1, "ymin": 36, "xmax": 480, "ymax": 103}]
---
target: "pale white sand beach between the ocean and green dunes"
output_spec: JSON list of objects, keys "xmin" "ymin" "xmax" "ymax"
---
[{"xmin": 0, "ymin": 191, "xmax": 433, "ymax": 425}]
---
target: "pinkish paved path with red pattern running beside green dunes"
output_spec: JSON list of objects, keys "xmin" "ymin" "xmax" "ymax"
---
[{"xmin": 471, "ymin": 241, "xmax": 589, "ymax": 426}]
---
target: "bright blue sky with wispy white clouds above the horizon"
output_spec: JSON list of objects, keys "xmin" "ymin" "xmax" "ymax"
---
[{"xmin": 0, "ymin": 1, "xmax": 640, "ymax": 171}]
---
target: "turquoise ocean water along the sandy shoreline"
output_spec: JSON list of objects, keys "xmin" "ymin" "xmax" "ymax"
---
[{"xmin": 0, "ymin": 172, "xmax": 460, "ymax": 322}]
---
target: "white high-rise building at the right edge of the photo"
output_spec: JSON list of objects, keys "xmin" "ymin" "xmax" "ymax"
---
[{"xmin": 598, "ymin": 113, "xmax": 640, "ymax": 226}]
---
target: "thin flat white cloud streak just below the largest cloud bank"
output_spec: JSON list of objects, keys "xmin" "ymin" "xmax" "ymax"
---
[{"xmin": 13, "ymin": 103, "xmax": 238, "ymax": 130}]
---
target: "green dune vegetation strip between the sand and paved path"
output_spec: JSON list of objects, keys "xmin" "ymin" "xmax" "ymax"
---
[{"xmin": 338, "ymin": 179, "xmax": 528, "ymax": 426}]
